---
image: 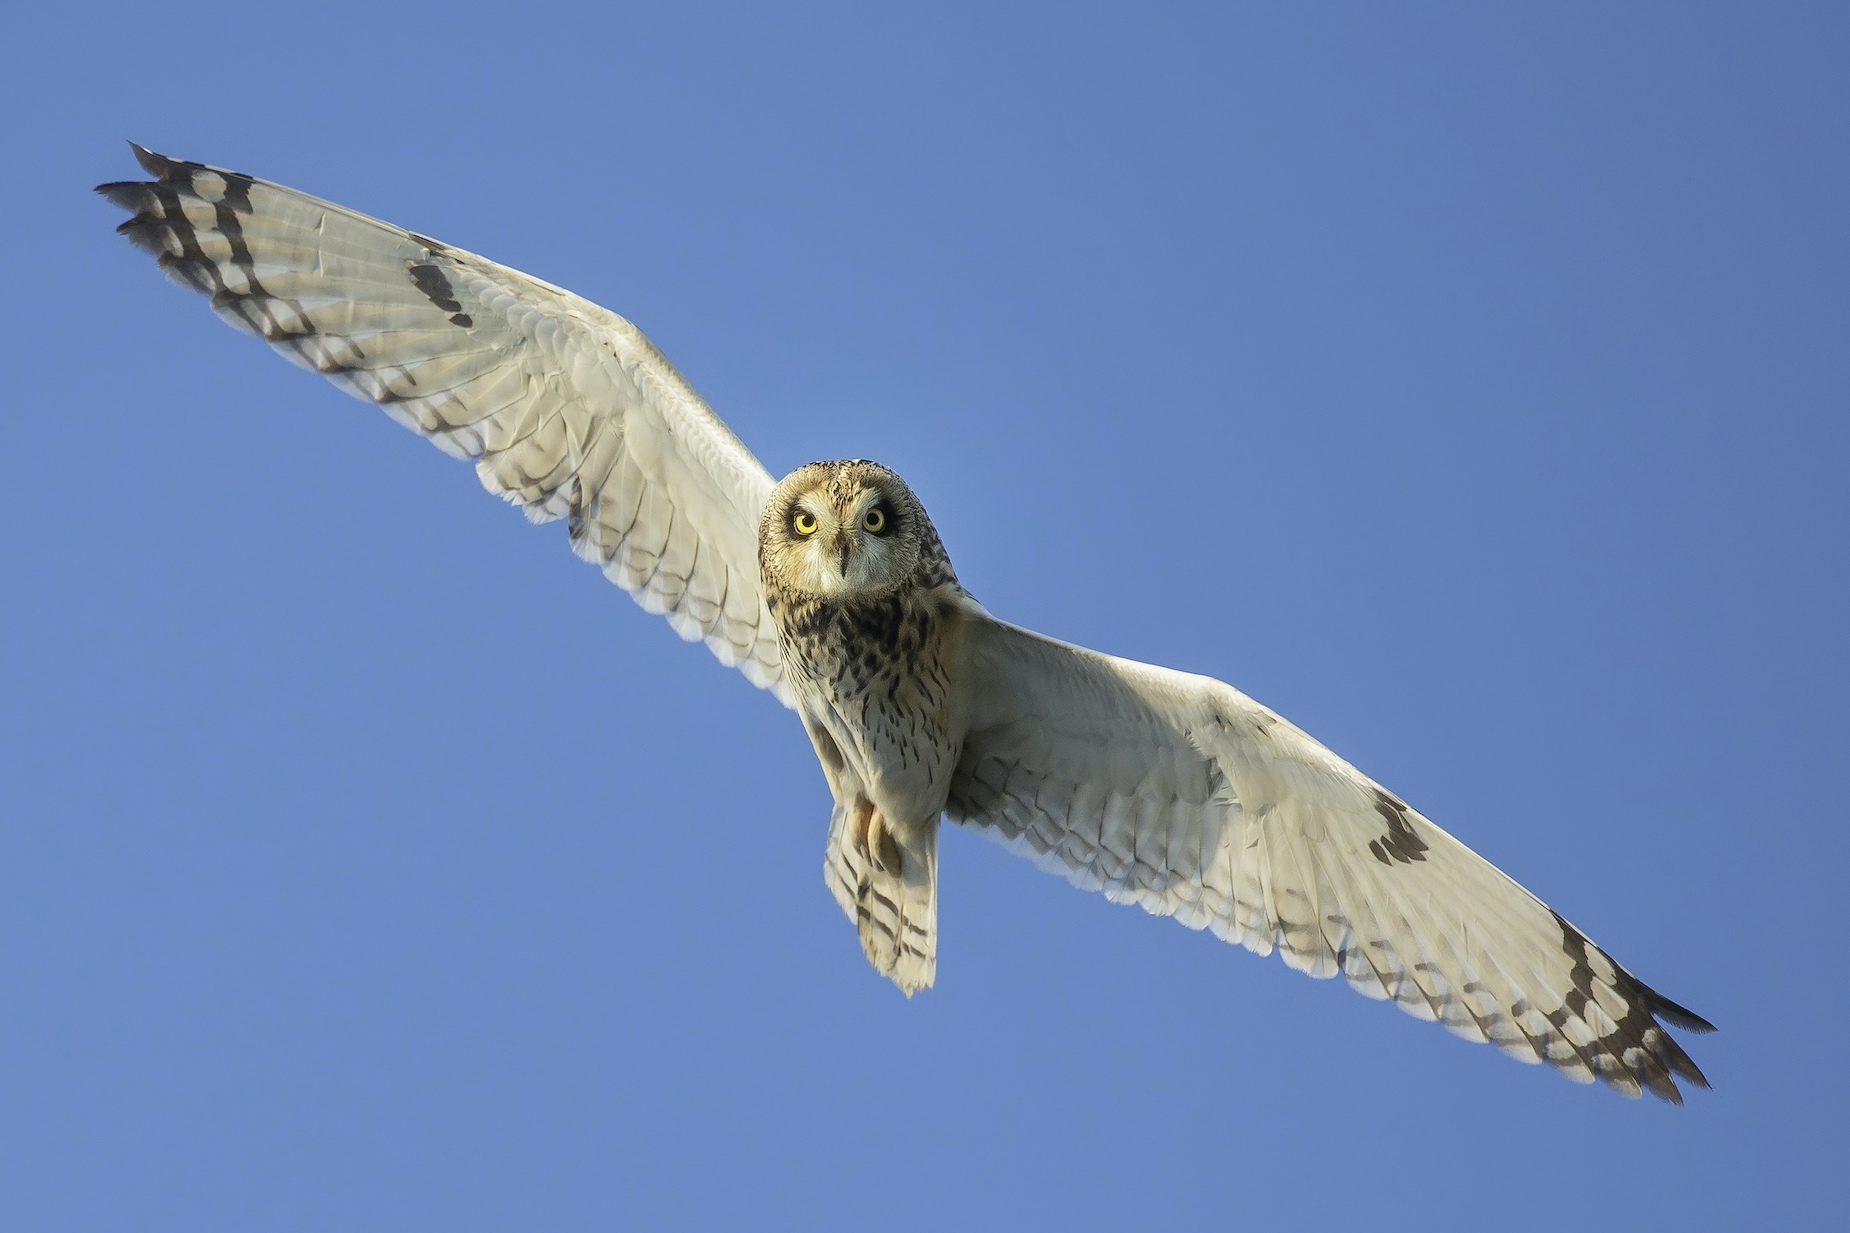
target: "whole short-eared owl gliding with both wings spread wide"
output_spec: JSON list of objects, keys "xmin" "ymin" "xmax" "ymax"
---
[{"xmin": 98, "ymin": 146, "xmax": 1711, "ymax": 1103}]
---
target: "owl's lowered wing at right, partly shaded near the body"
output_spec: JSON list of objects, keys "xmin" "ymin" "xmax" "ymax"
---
[{"xmin": 947, "ymin": 615, "xmax": 1713, "ymax": 1103}]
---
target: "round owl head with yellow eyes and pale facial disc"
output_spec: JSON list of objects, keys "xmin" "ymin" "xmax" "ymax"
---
[{"xmin": 759, "ymin": 459, "xmax": 931, "ymax": 600}]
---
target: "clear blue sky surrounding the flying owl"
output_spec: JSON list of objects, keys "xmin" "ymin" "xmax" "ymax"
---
[{"xmin": 0, "ymin": 4, "xmax": 1850, "ymax": 1233}]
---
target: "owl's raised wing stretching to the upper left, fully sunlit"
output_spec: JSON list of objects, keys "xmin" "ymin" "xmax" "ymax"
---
[{"xmin": 96, "ymin": 146, "xmax": 790, "ymax": 705}]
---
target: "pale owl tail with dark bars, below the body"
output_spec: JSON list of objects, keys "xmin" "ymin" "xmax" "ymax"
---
[{"xmin": 823, "ymin": 802, "xmax": 938, "ymax": 998}]
